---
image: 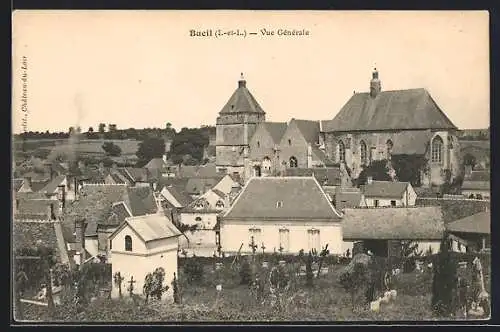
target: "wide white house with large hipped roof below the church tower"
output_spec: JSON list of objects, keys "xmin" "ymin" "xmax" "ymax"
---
[{"xmin": 220, "ymin": 177, "xmax": 342, "ymax": 254}]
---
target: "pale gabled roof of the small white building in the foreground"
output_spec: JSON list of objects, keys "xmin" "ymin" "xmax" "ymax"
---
[{"xmin": 110, "ymin": 214, "xmax": 182, "ymax": 242}]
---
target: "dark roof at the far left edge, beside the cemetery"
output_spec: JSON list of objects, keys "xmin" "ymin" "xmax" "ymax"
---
[{"xmin": 12, "ymin": 219, "xmax": 69, "ymax": 263}]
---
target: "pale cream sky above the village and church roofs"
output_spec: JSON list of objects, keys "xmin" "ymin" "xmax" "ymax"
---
[{"xmin": 12, "ymin": 11, "xmax": 490, "ymax": 132}]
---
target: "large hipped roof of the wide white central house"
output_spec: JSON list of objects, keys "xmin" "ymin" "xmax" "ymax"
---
[{"xmin": 224, "ymin": 177, "xmax": 340, "ymax": 221}]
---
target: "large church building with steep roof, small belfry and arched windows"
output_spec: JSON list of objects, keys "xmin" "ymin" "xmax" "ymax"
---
[{"xmin": 320, "ymin": 69, "xmax": 460, "ymax": 187}]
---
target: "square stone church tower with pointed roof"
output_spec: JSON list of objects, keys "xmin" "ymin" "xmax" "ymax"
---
[{"xmin": 215, "ymin": 73, "xmax": 266, "ymax": 177}]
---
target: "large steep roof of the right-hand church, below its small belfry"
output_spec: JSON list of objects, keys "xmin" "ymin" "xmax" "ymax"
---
[{"xmin": 323, "ymin": 88, "xmax": 457, "ymax": 132}]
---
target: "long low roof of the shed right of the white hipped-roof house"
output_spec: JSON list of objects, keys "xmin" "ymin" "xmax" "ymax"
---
[{"xmin": 342, "ymin": 206, "xmax": 444, "ymax": 240}]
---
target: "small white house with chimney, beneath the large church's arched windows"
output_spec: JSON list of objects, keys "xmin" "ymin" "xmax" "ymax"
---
[{"xmin": 361, "ymin": 177, "xmax": 417, "ymax": 207}]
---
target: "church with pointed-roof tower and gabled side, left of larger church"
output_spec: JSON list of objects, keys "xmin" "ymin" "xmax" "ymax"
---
[{"xmin": 216, "ymin": 74, "xmax": 331, "ymax": 180}]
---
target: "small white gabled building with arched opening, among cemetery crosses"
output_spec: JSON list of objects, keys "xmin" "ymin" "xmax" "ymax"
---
[{"xmin": 109, "ymin": 213, "xmax": 181, "ymax": 298}]
